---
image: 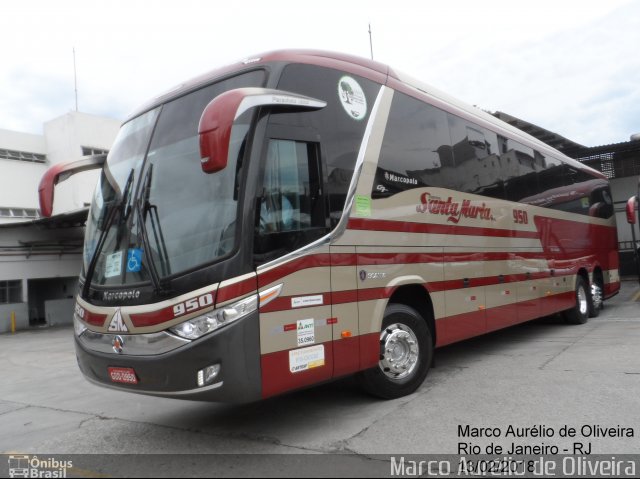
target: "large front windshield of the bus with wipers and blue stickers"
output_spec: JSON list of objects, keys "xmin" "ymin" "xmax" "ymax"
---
[{"xmin": 84, "ymin": 71, "xmax": 264, "ymax": 287}]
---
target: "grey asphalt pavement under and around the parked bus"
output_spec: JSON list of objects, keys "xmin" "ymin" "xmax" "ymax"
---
[{"xmin": 0, "ymin": 281, "xmax": 640, "ymax": 477}]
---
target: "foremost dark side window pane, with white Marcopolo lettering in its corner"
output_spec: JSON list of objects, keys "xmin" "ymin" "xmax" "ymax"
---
[{"xmin": 371, "ymin": 92, "xmax": 455, "ymax": 198}]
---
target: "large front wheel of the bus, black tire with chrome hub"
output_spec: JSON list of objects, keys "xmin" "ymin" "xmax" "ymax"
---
[{"xmin": 359, "ymin": 303, "xmax": 433, "ymax": 399}]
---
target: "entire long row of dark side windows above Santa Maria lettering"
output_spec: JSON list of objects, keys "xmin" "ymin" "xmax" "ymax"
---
[{"xmin": 372, "ymin": 88, "xmax": 613, "ymax": 218}]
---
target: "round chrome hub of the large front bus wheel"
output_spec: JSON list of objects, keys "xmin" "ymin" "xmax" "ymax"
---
[{"xmin": 379, "ymin": 324, "xmax": 420, "ymax": 379}]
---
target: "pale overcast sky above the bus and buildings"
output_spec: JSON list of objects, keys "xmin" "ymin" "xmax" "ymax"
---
[{"xmin": 0, "ymin": 0, "xmax": 640, "ymax": 146}]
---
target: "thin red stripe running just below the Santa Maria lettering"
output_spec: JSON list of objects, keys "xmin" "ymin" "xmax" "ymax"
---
[{"xmin": 347, "ymin": 218, "xmax": 540, "ymax": 239}]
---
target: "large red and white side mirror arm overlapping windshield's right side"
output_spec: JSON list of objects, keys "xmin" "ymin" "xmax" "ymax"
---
[{"xmin": 198, "ymin": 88, "xmax": 327, "ymax": 173}]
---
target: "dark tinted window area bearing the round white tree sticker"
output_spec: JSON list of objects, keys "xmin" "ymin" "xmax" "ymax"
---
[{"xmin": 270, "ymin": 65, "xmax": 380, "ymax": 225}]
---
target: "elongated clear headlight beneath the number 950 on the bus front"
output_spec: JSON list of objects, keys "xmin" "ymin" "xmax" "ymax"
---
[{"xmin": 169, "ymin": 295, "xmax": 258, "ymax": 339}]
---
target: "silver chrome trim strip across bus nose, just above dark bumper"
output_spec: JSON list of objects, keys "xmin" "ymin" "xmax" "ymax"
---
[{"xmin": 78, "ymin": 329, "xmax": 191, "ymax": 356}]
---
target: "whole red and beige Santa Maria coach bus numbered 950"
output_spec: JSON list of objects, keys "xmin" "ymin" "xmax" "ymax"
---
[{"xmin": 41, "ymin": 51, "xmax": 620, "ymax": 402}]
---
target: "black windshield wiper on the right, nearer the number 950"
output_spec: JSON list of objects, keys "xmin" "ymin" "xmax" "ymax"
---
[{"xmin": 136, "ymin": 164, "xmax": 171, "ymax": 295}]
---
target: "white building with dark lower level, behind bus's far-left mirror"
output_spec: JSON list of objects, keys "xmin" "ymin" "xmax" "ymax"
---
[{"xmin": 0, "ymin": 112, "xmax": 120, "ymax": 332}]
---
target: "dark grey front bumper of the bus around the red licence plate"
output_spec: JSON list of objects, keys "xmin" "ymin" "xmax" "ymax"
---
[{"xmin": 75, "ymin": 311, "xmax": 262, "ymax": 403}]
